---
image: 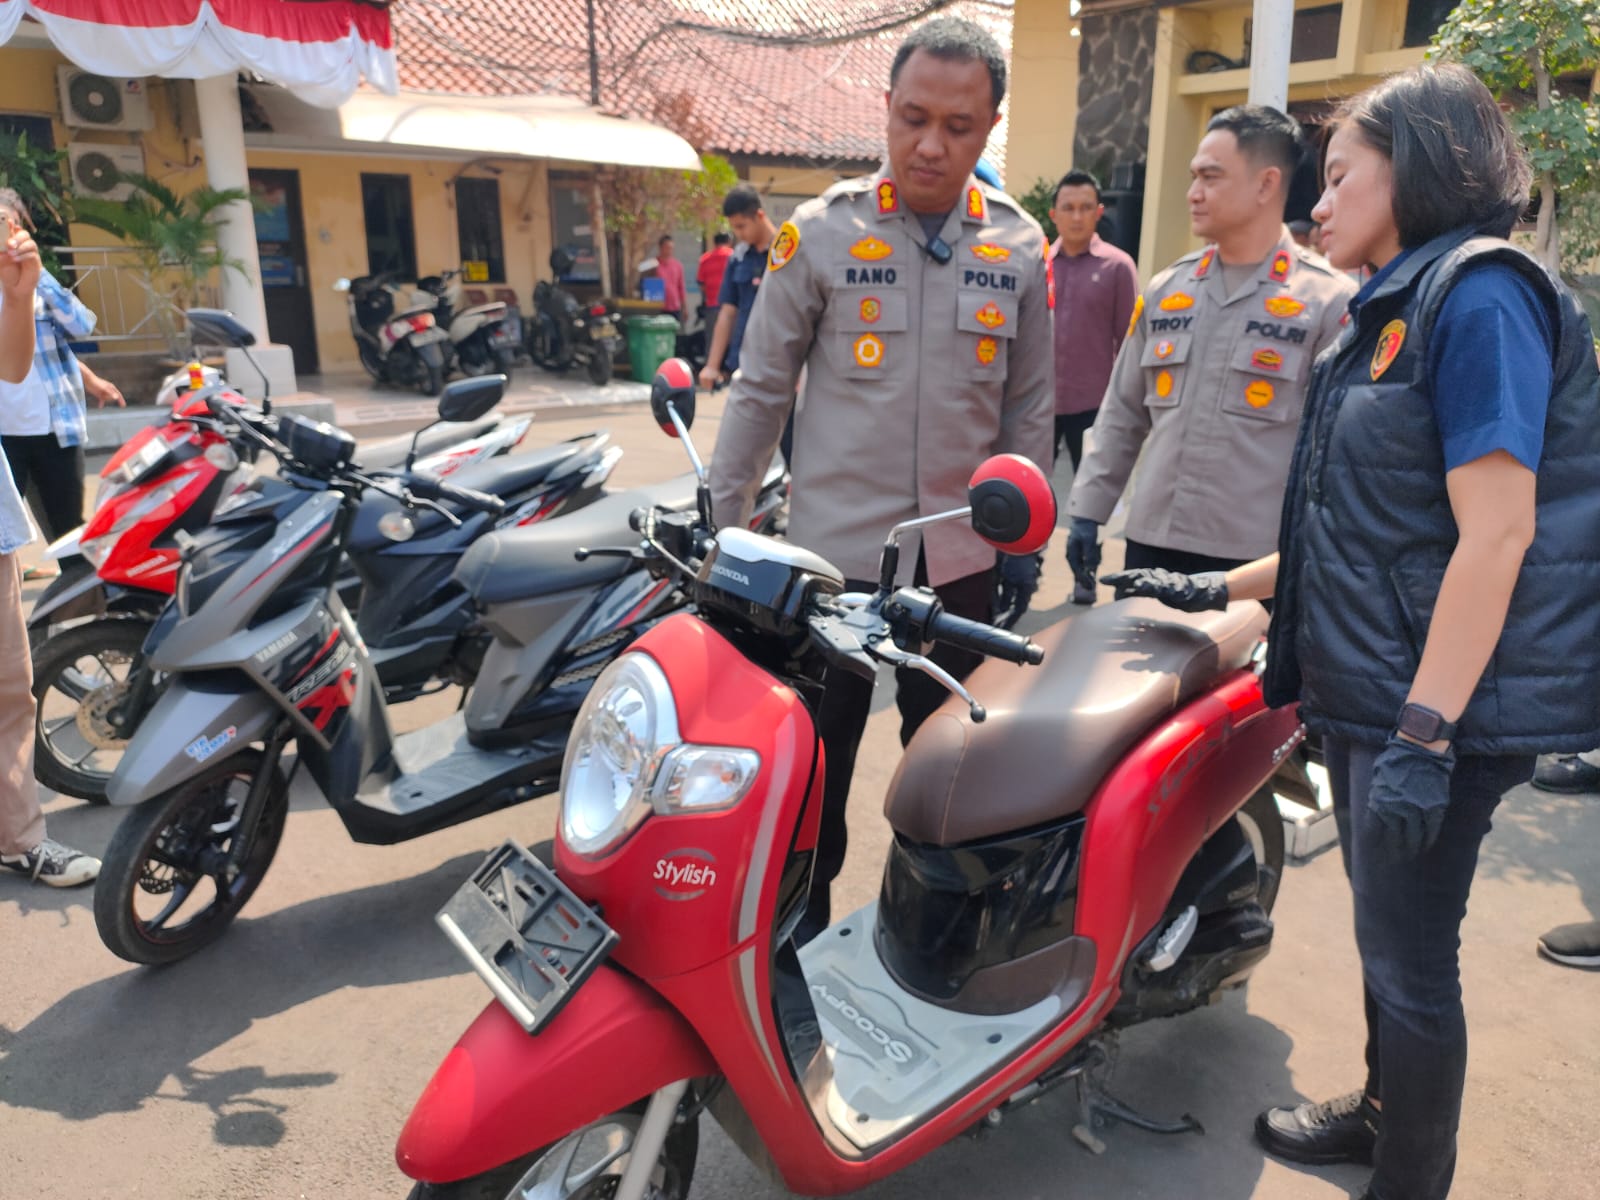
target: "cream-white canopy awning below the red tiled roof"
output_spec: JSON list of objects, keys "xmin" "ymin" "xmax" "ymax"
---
[{"xmin": 339, "ymin": 91, "xmax": 701, "ymax": 171}]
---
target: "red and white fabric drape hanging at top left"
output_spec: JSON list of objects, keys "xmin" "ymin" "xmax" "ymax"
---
[{"xmin": 0, "ymin": 0, "xmax": 398, "ymax": 107}]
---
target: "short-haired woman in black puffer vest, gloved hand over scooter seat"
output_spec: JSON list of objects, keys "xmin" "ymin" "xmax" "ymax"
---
[{"xmin": 1106, "ymin": 67, "xmax": 1600, "ymax": 1200}]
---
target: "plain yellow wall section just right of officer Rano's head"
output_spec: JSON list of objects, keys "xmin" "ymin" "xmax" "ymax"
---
[{"xmin": 1006, "ymin": 0, "xmax": 1082, "ymax": 195}]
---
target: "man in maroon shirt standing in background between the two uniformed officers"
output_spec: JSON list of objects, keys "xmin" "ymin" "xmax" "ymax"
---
[{"xmin": 1050, "ymin": 171, "xmax": 1139, "ymax": 470}]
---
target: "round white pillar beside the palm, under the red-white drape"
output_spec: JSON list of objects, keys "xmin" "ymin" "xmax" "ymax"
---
[{"xmin": 195, "ymin": 72, "xmax": 298, "ymax": 400}]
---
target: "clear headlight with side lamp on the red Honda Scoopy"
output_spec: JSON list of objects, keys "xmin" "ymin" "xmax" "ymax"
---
[{"xmin": 562, "ymin": 653, "xmax": 762, "ymax": 858}]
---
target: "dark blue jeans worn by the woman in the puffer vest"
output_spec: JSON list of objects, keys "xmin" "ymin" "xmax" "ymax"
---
[{"xmin": 1323, "ymin": 738, "xmax": 1534, "ymax": 1200}]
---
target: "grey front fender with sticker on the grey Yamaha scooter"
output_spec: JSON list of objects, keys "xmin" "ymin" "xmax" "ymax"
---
[{"xmin": 106, "ymin": 680, "xmax": 283, "ymax": 806}]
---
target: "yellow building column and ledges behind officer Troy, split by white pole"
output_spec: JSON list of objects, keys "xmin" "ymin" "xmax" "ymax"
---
[{"xmin": 1139, "ymin": 0, "xmax": 1424, "ymax": 278}]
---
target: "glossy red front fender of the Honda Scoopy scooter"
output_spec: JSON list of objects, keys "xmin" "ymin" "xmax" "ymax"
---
[{"xmin": 395, "ymin": 965, "xmax": 717, "ymax": 1184}]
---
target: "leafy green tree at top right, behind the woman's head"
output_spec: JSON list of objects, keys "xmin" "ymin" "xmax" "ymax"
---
[{"xmin": 1432, "ymin": 0, "xmax": 1600, "ymax": 270}]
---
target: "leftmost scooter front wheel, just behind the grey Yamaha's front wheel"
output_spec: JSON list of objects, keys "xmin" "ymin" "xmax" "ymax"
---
[{"xmin": 34, "ymin": 618, "xmax": 150, "ymax": 805}]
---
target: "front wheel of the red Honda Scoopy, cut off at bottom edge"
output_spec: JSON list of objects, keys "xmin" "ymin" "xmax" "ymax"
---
[{"xmin": 410, "ymin": 1104, "xmax": 699, "ymax": 1200}]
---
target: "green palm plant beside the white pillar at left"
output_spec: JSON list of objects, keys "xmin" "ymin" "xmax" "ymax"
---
[{"xmin": 77, "ymin": 174, "xmax": 251, "ymax": 355}]
